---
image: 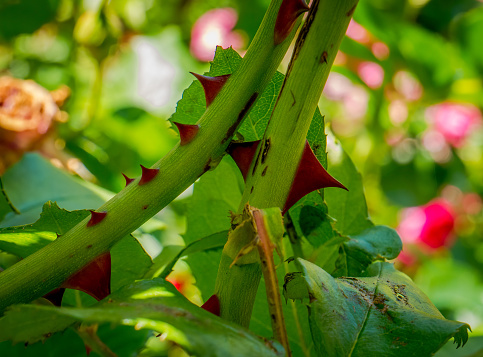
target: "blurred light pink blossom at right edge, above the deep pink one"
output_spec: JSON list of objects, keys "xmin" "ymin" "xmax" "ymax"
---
[{"xmin": 426, "ymin": 102, "xmax": 482, "ymax": 147}]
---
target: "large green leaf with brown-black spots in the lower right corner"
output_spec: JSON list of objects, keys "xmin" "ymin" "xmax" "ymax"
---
[{"xmin": 286, "ymin": 259, "xmax": 470, "ymax": 357}]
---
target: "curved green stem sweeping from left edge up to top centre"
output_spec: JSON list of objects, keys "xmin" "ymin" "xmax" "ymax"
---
[{"xmin": 0, "ymin": 0, "xmax": 294, "ymax": 312}]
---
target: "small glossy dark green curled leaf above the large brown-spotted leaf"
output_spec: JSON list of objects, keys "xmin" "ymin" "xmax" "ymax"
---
[{"xmin": 332, "ymin": 226, "xmax": 402, "ymax": 276}]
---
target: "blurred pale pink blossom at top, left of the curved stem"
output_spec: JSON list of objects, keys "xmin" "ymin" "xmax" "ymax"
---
[{"xmin": 190, "ymin": 8, "xmax": 245, "ymax": 61}]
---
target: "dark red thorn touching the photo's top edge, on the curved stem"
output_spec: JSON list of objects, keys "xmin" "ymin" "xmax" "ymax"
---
[{"xmin": 274, "ymin": 0, "xmax": 309, "ymax": 46}]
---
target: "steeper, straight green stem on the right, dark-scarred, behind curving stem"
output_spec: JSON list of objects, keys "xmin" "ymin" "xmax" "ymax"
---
[{"xmin": 216, "ymin": 0, "xmax": 357, "ymax": 326}]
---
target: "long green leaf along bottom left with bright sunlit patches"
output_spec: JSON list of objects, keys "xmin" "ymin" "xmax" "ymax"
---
[{"xmin": 0, "ymin": 278, "xmax": 283, "ymax": 356}]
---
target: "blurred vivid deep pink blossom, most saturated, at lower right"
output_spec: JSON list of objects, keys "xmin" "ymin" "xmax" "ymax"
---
[{"xmin": 397, "ymin": 198, "xmax": 456, "ymax": 264}]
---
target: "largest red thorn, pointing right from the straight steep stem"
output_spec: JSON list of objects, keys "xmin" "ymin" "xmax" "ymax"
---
[{"xmin": 282, "ymin": 141, "xmax": 347, "ymax": 214}]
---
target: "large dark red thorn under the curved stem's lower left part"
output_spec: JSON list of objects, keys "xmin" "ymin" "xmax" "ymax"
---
[{"xmin": 61, "ymin": 252, "xmax": 111, "ymax": 300}]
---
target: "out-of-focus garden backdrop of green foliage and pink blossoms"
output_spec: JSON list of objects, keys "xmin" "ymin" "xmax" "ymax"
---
[{"xmin": 0, "ymin": 0, "xmax": 483, "ymax": 356}]
